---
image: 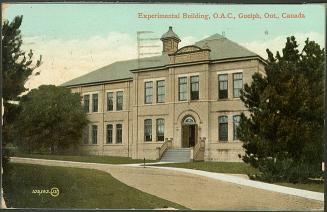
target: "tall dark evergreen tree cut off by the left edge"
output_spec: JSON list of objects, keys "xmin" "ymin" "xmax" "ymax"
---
[{"xmin": 2, "ymin": 16, "xmax": 41, "ymax": 172}]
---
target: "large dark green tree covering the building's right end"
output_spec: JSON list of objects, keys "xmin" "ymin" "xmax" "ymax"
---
[{"xmin": 238, "ymin": 36, "xmax": 325, "ymax": 182}]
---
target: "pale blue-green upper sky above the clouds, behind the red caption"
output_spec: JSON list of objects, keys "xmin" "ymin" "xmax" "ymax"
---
[{"xmin": 5, "ymin": 4, "xmax": 325, "ymax": 42}]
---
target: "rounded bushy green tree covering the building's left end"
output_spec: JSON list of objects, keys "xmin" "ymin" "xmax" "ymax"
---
[{"xmin": 14, "ymin": 85, "xmax": 88, "ymax": 153}]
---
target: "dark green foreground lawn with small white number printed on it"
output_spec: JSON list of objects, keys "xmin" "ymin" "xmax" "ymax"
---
[{"xmin": 3, "ymin": 163, "xmax": 185, "ymax": 209}]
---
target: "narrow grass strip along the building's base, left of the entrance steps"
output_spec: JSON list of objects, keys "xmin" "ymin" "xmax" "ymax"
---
[{"xmin": 14, "ymin": 153, "xmax": 155, "ymax": 164}]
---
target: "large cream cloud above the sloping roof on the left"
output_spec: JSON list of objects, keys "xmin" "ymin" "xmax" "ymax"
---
[{"xmin": 22, "ymin": 32, "xmax": 137, "ymax": 89}]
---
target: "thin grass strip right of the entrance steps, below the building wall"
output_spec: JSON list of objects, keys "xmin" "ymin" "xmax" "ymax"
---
[{"xmin": 154, "ymin": 162, "xmax": 258, "ymax": 174}]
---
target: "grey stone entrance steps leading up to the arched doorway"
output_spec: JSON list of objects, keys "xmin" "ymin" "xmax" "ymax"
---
[{"xmin": 160, "ymin": 148, "xmax": 191, "ymax": 163}]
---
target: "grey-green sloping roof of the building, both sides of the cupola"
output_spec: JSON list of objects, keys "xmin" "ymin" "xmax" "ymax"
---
[{"xmin": 61, "ymin": 34, "xmax": 258, "ymax": 86}]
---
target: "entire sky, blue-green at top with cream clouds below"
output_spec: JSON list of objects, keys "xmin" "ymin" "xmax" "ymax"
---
[{"xmin": 3, "ymin": 3, "xmax": 326, "ymax": 88}]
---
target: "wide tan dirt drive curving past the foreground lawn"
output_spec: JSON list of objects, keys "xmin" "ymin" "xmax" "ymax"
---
[{"xmin": 10, "ymin": 157, "xmax": 324, "ymax": 210}]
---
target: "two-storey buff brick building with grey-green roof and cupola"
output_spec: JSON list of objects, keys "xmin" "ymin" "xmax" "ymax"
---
[{"xmin": 63, "ymin": 27, "xmax": 264, "ymax": 161}]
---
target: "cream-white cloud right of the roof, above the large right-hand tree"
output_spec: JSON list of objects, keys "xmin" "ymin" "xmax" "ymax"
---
[{"xmin": 240, "ymin": 32, "xmax": 325, "ymax": 59}]
